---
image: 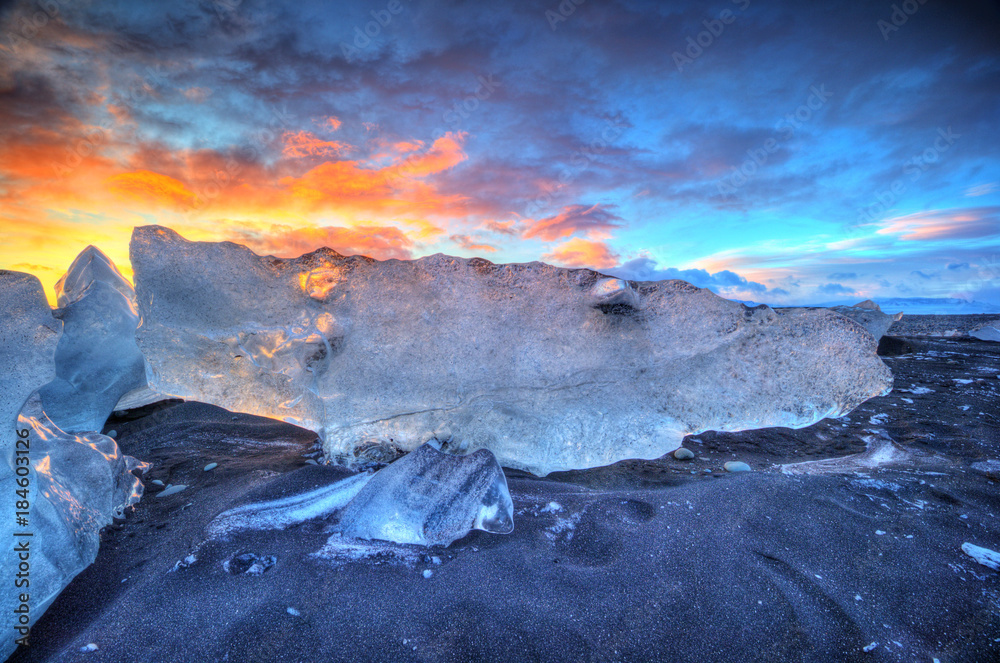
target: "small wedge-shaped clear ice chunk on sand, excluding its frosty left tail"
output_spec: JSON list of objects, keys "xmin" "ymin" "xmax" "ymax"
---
[{"xmin": 335, "ymin": 444, "xmax": 514, "ymax": 546}]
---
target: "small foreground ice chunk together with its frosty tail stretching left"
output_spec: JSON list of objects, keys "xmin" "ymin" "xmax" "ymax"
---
[{"xmin": 207, "ymin": 444, "xmax": 514, "ymax": 546}]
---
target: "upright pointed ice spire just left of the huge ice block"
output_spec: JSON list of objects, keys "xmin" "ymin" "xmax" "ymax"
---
[{"xmin": 40, "ymin": 246, "xmax": 146, "ymax": 433}]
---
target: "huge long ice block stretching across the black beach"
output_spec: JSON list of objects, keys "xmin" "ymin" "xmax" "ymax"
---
[{"xmin": 131, "ymin": 226, "xmax": 892, "ymax": 475}]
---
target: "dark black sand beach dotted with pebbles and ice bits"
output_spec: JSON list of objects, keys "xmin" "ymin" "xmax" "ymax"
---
[{"xmin": 10, "ymin": 338, "xmax": 1000, "ymax": 663}]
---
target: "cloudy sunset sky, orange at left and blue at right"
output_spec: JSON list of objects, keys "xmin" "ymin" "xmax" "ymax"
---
[{"xmin": 0, "ymin": 0, "xmax": 1000, "ymax": 310}]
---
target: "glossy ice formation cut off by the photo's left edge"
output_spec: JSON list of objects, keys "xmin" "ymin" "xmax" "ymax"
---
[{"xmin": 0, "ymin": 271, "xmax": 142, "ymax": 659}]
